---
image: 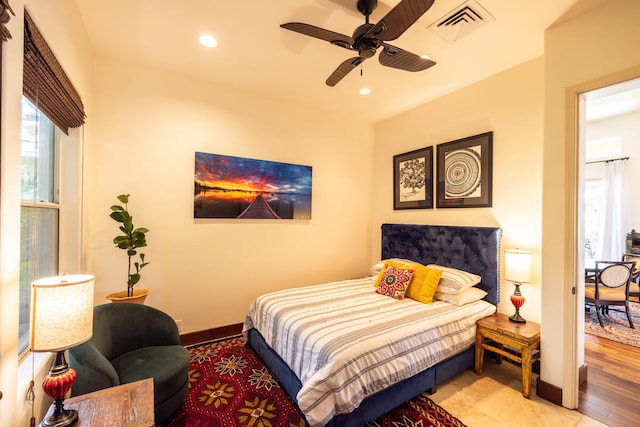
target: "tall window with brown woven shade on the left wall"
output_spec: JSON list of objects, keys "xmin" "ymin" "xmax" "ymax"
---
[{"xmin": 18, "ymin": 10, "xmax": 85, "ymax": 353}]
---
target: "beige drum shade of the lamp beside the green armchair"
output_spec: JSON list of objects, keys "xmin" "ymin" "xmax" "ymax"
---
[{"xmin": 29, "ymin": 274, "xmax": 93, "ymax": 352}]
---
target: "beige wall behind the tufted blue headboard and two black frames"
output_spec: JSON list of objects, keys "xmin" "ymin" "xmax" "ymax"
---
[{"xmin": 372, "ymin": 58, "xmax": 544, "ymax": 321}]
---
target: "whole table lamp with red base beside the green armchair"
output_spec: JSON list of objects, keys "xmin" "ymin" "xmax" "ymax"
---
[{"xmin": 29, "ymin": 274, "xmax": 93, "ymax": 427}]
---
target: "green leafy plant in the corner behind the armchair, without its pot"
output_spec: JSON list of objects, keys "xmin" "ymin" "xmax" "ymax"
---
[{"xmin": 109, "ymin": 194, "xmax": 149, "ymax": 297}]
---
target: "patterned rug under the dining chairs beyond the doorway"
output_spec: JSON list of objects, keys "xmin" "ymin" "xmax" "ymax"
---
[{"xmin": 584, "ymin": 302, "xmax": 640, "ymax": 347}]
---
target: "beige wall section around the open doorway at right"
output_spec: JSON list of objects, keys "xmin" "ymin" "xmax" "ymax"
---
[{"xmin": 541, "ymin": 0, "xmax": 640, "ymax": 407}]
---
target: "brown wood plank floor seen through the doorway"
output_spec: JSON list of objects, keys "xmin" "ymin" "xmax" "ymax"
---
[{"xmin": 578, "ymin": 334, "xmax": 640, "ymax": 427}]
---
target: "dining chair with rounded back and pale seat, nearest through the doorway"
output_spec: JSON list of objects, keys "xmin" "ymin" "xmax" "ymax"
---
[{"xmin": 584, "ymin": 261, "xmax": 636, "ymax": 329}]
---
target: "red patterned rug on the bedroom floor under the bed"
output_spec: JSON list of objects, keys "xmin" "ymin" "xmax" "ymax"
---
[{"xmin": 168, "ymin": 336, "xmax": 465, "ymax": 427}]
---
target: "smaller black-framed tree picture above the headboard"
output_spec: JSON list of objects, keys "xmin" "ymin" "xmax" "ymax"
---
[{"xmin": 393, "ymin": 147, "xmax": 433, "ymax": 209}]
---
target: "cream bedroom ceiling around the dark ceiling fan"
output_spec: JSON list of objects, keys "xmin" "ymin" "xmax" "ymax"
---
[{"xmin": 77, "ymin": 0, "xmax": 602, "ymax": 122}]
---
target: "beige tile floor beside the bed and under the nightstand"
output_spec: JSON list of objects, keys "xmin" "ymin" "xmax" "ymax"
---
[{"xmin": 430, "ymin": 361, "xmax": 605, "ymax": 427}]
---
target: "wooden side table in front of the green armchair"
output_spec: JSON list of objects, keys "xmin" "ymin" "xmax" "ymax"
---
[{"xmin": 45, "ymin": 378, "xmax": 155, "ymax": 427}]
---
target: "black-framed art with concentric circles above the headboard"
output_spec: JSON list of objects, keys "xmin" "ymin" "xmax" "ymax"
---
[{"xmin": 436, "ymin": 132, "xmax": 493, "ymax": 208}]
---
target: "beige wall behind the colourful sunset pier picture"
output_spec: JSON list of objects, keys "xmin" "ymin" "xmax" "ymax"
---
[{"xmin": 85, "ymin": 58, "xmax": 372, "ymax": 332}]
